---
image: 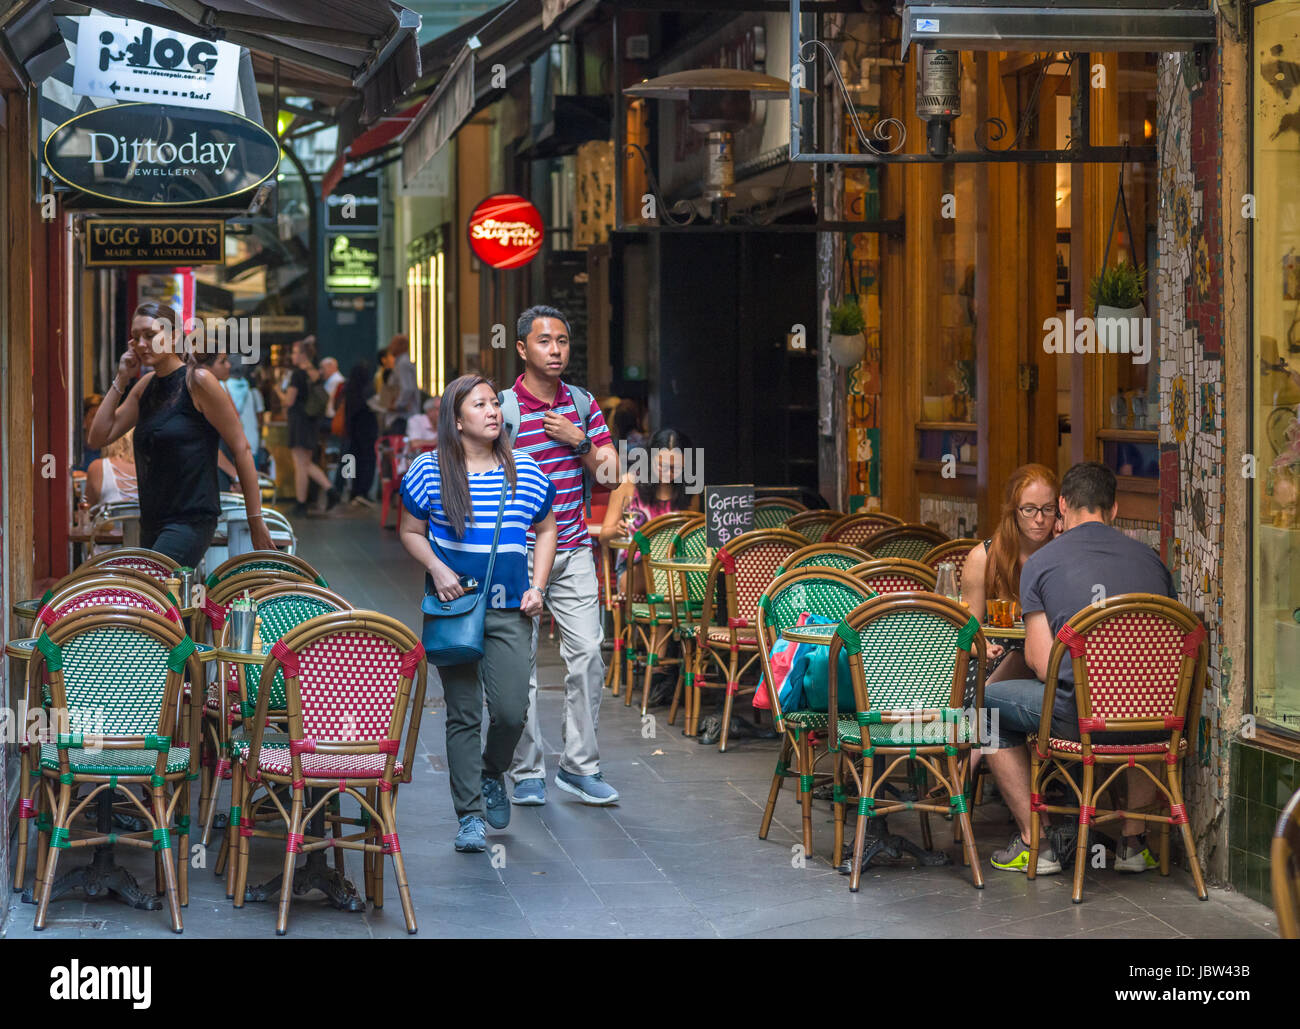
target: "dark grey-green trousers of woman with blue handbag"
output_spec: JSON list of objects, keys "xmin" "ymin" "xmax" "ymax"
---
[{"xmin": 438, "ymin": 608, "xmax": 537, "ymax": 819}]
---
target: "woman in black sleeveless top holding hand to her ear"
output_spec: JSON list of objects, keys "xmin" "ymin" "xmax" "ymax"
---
[{"xmin": 87, "ymin": 301, "xmax": 272, "ymax": 566}]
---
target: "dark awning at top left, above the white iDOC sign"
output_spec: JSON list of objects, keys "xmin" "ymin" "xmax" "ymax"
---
[{"xmin": 60, "ymin": 0, "xmax": 420, "ymax": 125}]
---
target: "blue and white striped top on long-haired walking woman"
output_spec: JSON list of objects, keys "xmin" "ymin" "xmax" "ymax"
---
[{"xmin": 402, "ymin": 451, "xmax": 555, "ymax": 608}]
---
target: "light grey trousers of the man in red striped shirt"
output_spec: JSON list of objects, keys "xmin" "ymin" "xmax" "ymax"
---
[{"xmin": 510, "ymin": 547, "xmax": 605, "ymax": 782}]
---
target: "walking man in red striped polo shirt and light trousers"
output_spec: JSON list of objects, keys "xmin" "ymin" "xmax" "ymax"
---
[{"xmin": 502, "ymin": 307, "xmax": 619, "ymax": 804}]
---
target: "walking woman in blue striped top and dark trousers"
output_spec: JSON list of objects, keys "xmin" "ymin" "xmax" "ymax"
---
[{"xmin": 400, "ymin": 375, "xmax": 556, "ymax": 852}]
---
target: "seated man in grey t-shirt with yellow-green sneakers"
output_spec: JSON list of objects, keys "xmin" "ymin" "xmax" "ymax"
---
[{"xmin": 983, "ymin": 461, "xmax": 1174, "ymax": 876}]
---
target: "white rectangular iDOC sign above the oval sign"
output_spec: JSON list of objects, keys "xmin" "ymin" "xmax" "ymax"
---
[{"xmin": 73, "ymin": 14, "xmax": 239, "ymax": 110}]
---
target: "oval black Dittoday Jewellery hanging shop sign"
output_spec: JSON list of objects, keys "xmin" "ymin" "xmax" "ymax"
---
[{"xmin": 46, "ymin": 104, "xmax": 280, "ymax": 207}]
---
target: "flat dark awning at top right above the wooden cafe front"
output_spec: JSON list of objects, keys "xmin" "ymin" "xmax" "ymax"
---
[{"xmin": 902, "ymin": 0, "xmax": 1214, "ymax": 60}]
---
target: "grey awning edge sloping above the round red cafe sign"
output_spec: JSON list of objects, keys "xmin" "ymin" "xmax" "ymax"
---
[{"xmin": 400, "ymin": 0, "xmax": 599, "ymax": 183}]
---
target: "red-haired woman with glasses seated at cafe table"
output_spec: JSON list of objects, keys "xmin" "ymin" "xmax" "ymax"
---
[{"xmin": 962, "ymin": 464, "xmax": 1061, "ymax": 678}]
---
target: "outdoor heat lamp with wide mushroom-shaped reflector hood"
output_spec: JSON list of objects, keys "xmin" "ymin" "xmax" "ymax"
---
[{"xmin": 623, "ymin": 68, "xmax": 813, "ymax": 220}]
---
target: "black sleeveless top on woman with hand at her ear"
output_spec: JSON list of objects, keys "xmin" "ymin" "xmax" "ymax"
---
[{"xmin": 135, "ymin": 365, "xmax": 221, "ymax": 526}]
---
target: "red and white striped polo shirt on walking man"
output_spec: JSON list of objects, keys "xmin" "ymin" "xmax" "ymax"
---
[{"xmin": 515, "ymin": 375, "xmax": 614, "ymax": 551}]
